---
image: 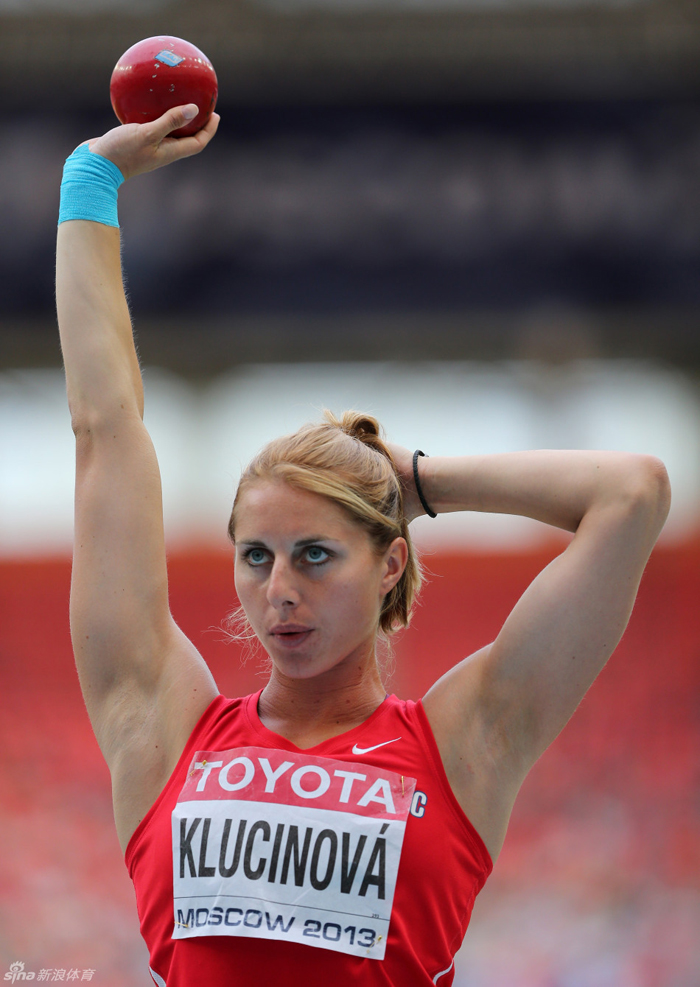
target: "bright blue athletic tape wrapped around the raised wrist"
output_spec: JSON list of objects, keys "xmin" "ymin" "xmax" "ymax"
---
[{"xmin": 58, "ymin": 144, "xmax": 124, "ymax": 227}]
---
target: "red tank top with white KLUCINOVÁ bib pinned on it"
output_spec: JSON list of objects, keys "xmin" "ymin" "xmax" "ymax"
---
[{"xmin": 126, "ymin": 693, "xmax": 492, "ymax": 987}]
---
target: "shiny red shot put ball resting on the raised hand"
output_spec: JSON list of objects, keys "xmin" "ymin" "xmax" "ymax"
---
[{"xmin": 109, "ymin": 34, "xmax": 219, "ymax": 137}]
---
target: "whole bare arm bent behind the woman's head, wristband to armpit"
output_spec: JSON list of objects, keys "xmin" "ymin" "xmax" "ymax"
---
[{"xmin": 420, "ymin": 451, "xmax": 670, "ymax": 856}]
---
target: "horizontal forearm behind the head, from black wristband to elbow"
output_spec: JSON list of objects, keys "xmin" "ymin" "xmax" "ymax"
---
[{"xmin": 420, "ymin": 450, "xmax": 668, "ymax": 531}]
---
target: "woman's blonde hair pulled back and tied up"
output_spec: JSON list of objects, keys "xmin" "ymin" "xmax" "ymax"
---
[{"xmin": 228, "ymin": 411, "xmax": 421, "ymax": 635}]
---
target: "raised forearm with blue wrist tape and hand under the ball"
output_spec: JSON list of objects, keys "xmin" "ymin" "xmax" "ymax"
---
[{"xmin": 56, "ymin": 104, "xmax": 219, "ymax": 430}]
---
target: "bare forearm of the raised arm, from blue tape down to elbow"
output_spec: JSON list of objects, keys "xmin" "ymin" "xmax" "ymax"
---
[{"xmin": 56, "ymin": 220, "xmax": 143, "ymax": 426}]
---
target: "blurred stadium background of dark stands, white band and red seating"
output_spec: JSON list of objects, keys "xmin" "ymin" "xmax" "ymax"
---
[{"xmin": 0, "ymin": 0, "xmax": 700, "ymax": 987}]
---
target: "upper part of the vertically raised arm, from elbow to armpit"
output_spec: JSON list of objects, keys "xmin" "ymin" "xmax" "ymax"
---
[{"xmin": 71, "ymin": 414, "xmax": 215, "ymax": 749}]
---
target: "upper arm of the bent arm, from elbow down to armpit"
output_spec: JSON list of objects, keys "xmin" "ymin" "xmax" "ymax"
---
[{"xmin": 424, "ymin": 461, "xmax": 669, "ymax": 854}]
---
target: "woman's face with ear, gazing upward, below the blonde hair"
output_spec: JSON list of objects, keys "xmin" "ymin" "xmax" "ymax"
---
[{"xmin": 235, "ymin": 480, "xmax": 406, "ymax": 678}]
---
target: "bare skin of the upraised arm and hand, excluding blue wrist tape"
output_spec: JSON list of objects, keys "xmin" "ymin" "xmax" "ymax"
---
[{"xmin": 56, "ymin": 107, "xmax": 218, "ymax": 846}]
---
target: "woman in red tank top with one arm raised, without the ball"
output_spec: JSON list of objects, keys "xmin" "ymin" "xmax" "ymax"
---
[{"xmin": 57, "ymin": 106, "xmax": 669, "ymax": 987}]
